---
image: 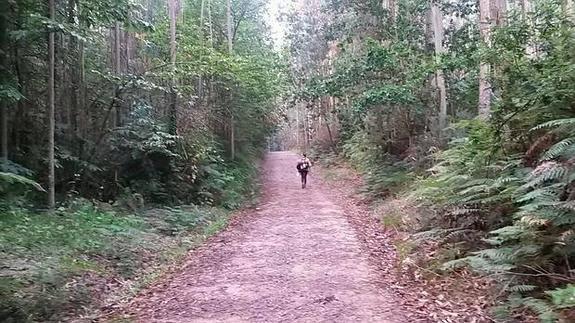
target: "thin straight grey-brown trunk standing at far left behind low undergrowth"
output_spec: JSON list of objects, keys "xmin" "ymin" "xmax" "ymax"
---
[{"xmin": 48, "ymin": 0, "xmax": 56, "ymax": 209}]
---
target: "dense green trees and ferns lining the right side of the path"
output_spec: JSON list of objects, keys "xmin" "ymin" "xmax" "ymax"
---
[{"xmin": 290, "ymin": 0, "xmax": 575, "ymax": 321}]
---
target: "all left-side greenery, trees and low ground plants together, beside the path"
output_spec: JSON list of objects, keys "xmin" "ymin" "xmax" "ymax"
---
[{"xmin": 0, "ymin": 0, "xmax": 284, "ymax": 322}]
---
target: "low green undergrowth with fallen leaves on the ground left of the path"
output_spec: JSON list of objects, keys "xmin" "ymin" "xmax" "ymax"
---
[{"xmin": 0, "ymin": 201, "xmax": 228, "ymax": 322}]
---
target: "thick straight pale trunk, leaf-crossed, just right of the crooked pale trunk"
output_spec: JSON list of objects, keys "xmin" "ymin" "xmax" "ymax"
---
[{"xmin": 478, "ymin": 0, "xmax": 493, "ymax": 120}]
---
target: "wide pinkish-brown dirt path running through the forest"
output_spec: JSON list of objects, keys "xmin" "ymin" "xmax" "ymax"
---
[{"xmin": 124, "ymin": 153, "xmax": 409, "ymax": 322}]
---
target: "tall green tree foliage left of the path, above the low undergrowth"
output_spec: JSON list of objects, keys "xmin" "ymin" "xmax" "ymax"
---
[{"xmin": 0, "ymin": 0, "xmax": 282, "ymax": 208}]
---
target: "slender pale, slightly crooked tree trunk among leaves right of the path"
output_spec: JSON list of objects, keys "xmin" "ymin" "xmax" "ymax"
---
[{"xmin": 431, "ymin": 2, "xmax": 447, "ymax": 135}]
